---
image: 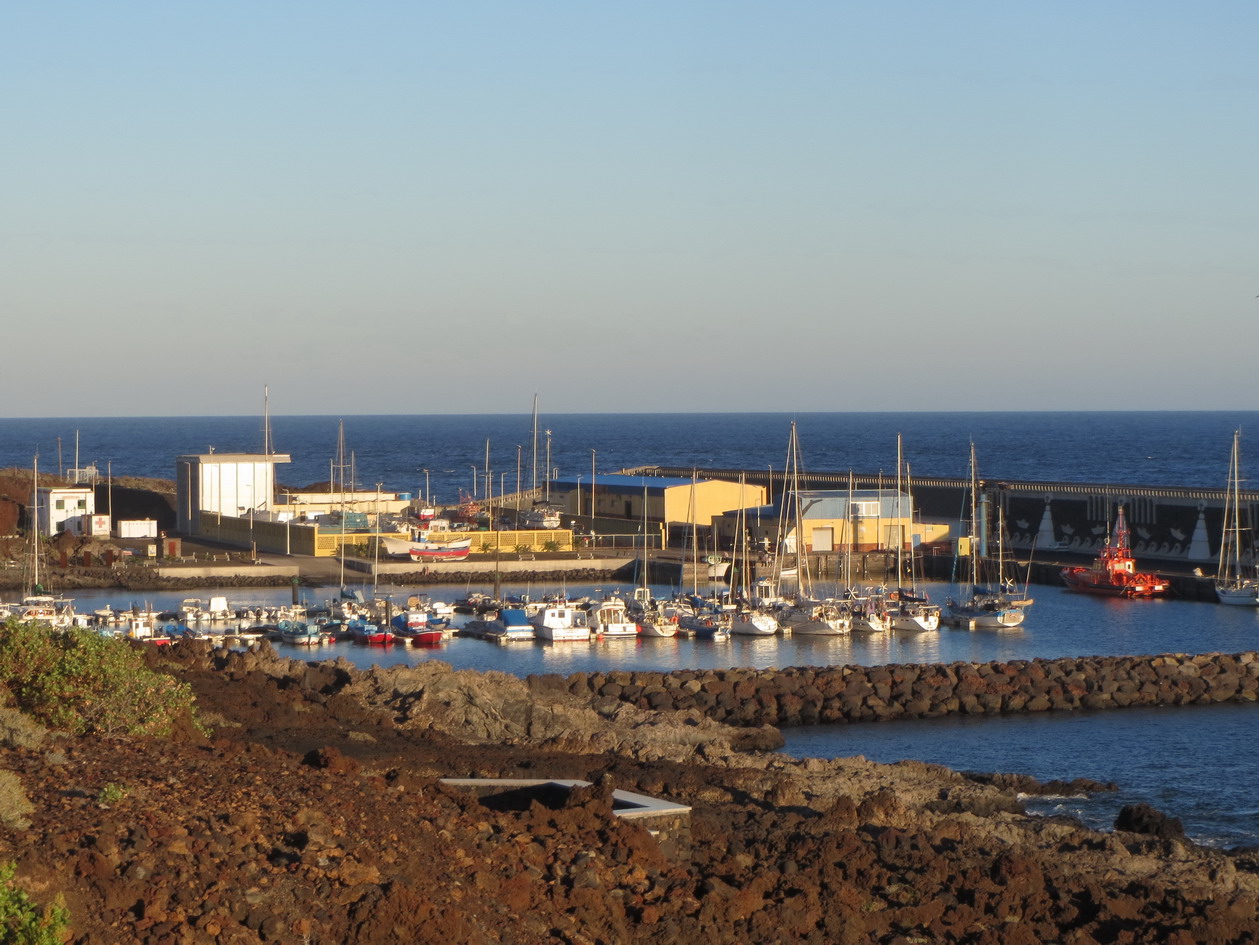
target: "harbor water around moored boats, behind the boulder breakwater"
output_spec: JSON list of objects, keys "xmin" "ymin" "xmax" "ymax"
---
[{"xmin": 34, "ymin": 573, "xmax": 1259, "ymax": 676}]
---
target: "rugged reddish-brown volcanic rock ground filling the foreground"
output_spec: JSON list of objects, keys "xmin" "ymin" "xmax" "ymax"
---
[{"xmin": 0, "ymin": 642, "xmax": 1259, "ymax": 945}]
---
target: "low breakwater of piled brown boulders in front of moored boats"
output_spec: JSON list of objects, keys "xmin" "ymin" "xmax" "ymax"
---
[{"xmin": 556, "ymin": 651, "xmax": 1259, "ymax": 727}]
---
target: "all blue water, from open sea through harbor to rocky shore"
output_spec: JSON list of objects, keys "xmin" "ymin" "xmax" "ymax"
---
[{"xmin": 0, "ymin": 411, "xmax": 1259, "ymax": 847}]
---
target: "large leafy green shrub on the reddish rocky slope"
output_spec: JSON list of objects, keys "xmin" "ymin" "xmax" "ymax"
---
[{"xmin": 0, "ymin": 620, "xmax": 195, "ymax": 735}]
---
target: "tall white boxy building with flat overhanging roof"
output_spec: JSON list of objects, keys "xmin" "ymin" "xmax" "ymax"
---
[{"xmin": 175, "ymin": 452, "xmax": 292, "ymax": 535}]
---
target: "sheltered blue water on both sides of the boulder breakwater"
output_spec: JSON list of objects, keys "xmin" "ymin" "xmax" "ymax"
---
[{"xmin": 54, "ymin": 584, "xmax": 1259, "ymax": 847}]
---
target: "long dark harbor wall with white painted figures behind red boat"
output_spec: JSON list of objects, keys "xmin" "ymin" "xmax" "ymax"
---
[{"xmin": 630, "ymin": 466, "xmax": 1259, "ymax": 574}]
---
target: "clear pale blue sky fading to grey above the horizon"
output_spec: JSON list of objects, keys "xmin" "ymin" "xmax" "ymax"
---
[{"xmin": 0, "ymin": 0, "xmax": 1259, "ymax": 417}]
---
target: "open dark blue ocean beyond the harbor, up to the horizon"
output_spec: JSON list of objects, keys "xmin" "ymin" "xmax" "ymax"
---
[{"xmin": 0, "ymin": 410, "xmax": 1259, "ymax": 502}]
